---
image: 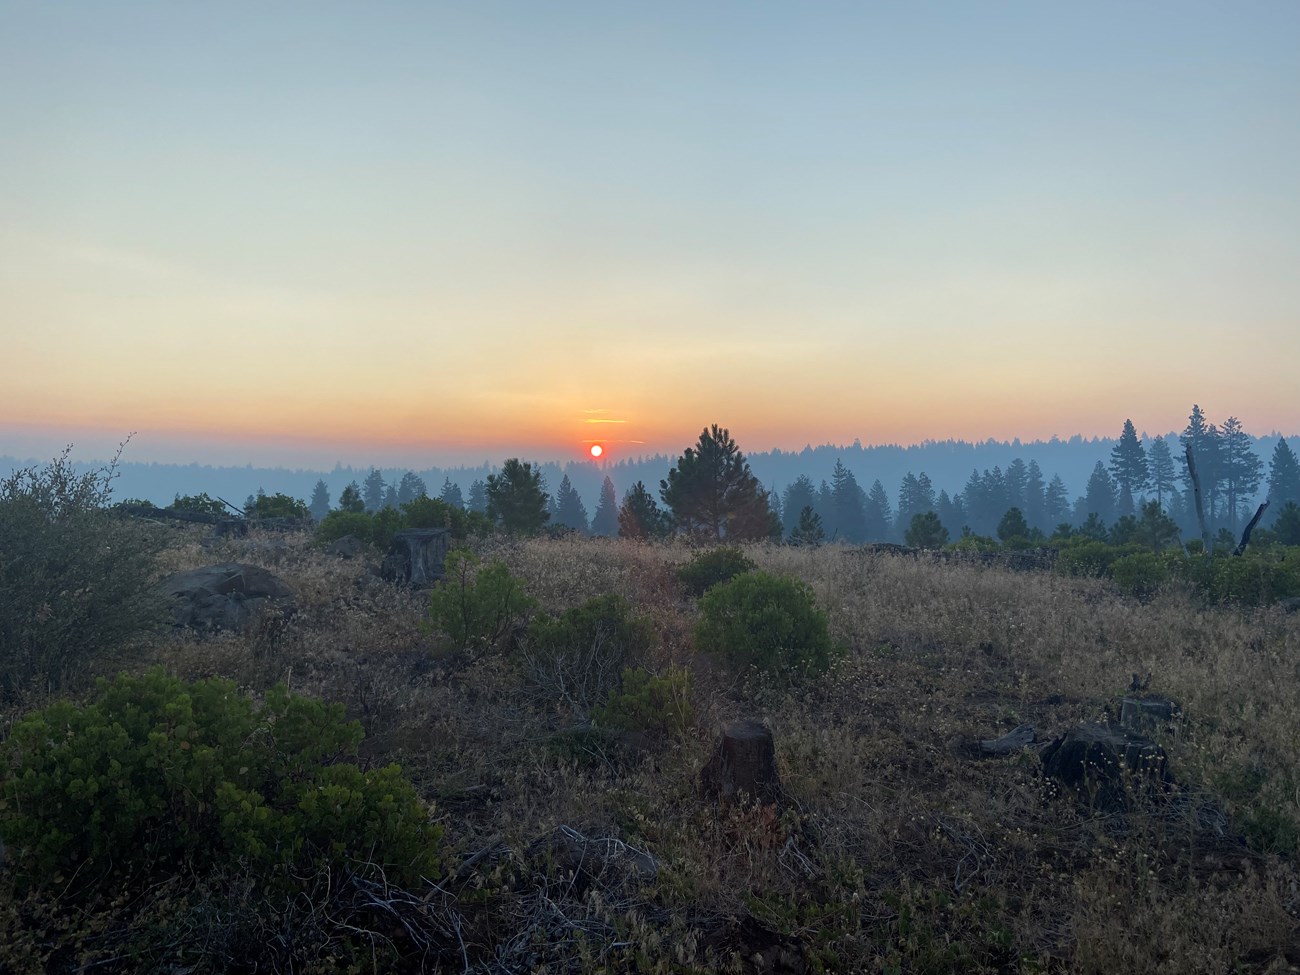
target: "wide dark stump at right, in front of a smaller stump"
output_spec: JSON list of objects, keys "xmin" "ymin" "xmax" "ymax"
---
[{"xmin": 1043, "ymin": 724, "xmax": 1169, "ymax": 813}]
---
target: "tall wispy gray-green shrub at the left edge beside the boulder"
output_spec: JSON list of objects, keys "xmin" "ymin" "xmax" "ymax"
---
[{"xmin": 0, "ymin": 451, "xmax": 166, "ymax": 701}]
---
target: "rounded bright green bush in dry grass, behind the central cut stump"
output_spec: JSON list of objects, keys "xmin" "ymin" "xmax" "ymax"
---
[{"xmin": 696, "ymin": 572, "xmax": 837, "ymax": 679}]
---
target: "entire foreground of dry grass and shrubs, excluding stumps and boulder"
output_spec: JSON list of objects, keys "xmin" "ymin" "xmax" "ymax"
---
[{"xmin": 0, "ymin": 452, "xmax": 1300, "ymax": 972}]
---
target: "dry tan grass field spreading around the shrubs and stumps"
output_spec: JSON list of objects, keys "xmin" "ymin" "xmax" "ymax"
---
[{"xmin": 2, "ymin": 529, "xmax": 1300, "ymax": 975}]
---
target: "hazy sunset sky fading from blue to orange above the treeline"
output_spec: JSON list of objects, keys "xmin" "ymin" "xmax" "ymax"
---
[{"xmin": 0, "ymin": 0, "xmax": 1300, "ymax": 464}]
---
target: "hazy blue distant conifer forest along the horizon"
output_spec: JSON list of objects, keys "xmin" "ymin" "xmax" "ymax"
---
[{"xmin": 0, "ymin": 407, "xmax": 1300, "ymax": 542}]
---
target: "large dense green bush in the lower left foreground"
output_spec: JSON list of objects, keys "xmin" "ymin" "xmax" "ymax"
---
[{"xmin": 0, "ymin": 668, "xmax": 441, "ymax": 894}]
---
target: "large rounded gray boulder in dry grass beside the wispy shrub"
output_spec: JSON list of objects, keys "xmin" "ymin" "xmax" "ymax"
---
[{"xmin": 159, "ymin": 562, "xmax": 296, "ymax": 632}]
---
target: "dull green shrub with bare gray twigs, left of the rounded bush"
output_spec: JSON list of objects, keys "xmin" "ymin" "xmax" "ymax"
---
[{"xmin": 520, "ymin": 593, "xmax": 651, "ymax": 716}]
